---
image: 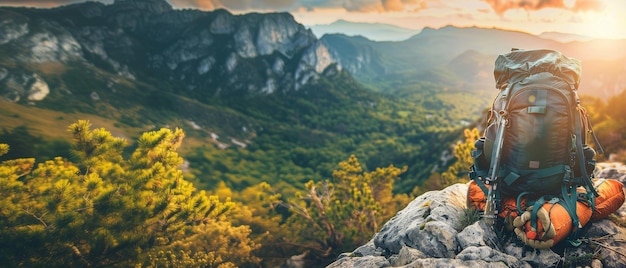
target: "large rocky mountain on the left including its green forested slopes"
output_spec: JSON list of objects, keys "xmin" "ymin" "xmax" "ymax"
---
[{"xmin": 0, "ymin": 0, "xmax": 465, "ymax": 195}]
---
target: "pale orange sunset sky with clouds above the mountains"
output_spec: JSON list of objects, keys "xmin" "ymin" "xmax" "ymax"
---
[{"xmin": 0, "ymin": 0, "xmax": 626, "ymax": 39}]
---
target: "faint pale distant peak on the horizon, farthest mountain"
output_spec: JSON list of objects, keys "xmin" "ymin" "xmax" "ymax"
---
[{"xmin": 309, "ymin": 20, "xmax": 420, "ymax": 41}]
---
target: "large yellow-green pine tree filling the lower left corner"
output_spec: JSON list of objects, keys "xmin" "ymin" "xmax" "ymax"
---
[{"xmin": 0, "ymin": 121, "xmax": 259, "ymax": 267}]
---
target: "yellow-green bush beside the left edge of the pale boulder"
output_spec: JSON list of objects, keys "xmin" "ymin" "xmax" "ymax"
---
[{"xmin": 281, "ymin": 155, "xmax": 408, "ymax": 264}]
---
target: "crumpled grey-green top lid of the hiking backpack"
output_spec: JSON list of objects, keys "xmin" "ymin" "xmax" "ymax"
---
[{"xmin": 493, "ymin": 49, "xmax": 582, "ymax": 89}]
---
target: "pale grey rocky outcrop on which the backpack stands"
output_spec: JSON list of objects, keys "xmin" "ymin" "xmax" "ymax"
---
[{"xmin": 327, "ymin": 163, "xmax": 626, "ymax": 268}]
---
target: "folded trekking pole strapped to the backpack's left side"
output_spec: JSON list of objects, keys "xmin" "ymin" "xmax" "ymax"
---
[{"xmin": 483, "ymin": 85, "xmax": 511, "ymax": 225}]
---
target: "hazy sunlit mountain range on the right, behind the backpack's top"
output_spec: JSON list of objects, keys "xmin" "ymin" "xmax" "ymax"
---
[{"xmin": 321, "ymin": 26, "xmax": 626, "ymax": 99}]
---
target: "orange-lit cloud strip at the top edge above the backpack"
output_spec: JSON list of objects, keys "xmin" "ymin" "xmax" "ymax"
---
[{"xmin": 483, "ymin": 0, "xmax": 603, "ymax": 15}]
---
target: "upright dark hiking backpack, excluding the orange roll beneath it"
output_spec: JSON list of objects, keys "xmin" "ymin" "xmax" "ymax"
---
[{"xmin": 470, "ymin": 49, "xmax": 603, "ymax": 245}]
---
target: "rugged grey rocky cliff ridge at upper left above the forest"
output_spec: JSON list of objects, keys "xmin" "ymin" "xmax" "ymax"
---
[{"xmin": 0, "ymin": 0, "xmax": 334, "ymax": 100}]
